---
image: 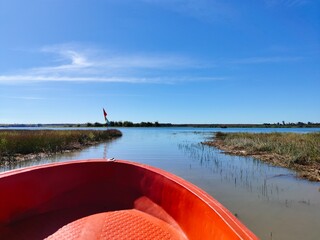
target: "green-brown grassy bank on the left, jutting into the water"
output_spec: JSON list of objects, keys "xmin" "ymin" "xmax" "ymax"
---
[{"xmin": 0, "ymin": 130, "xmax": 122, "ymax": 163}]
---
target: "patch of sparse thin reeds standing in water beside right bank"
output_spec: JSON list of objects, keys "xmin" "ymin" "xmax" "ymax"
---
[{"xmin": 178, "ymin": 142, "xmax": 313, "ymax": 208}]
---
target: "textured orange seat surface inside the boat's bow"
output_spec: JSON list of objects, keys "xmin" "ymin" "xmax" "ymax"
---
[{"xmin": 46, "ymin": 209, "xmax": 186, "ymax": 240}]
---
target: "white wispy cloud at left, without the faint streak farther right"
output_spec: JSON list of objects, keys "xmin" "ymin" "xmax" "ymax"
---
[{"xmin": 0, "ymin": 45, "xmax": 221, "ymax": 83}]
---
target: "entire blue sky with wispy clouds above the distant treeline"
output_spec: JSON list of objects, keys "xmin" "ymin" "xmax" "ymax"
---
[{"xmin": 0, "ymin": 0, "xmax": 320, "ymax": 123}]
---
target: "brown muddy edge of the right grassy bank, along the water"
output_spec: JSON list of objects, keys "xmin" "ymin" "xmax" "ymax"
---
[{"xmin": 202, "ymin": 132, "xmax": 320, "ymax": 182}]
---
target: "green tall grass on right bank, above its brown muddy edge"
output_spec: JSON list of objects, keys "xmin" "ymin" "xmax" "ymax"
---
[{"xmin": 216, "ymin": 132, "xmax": 320, "ymax": 165}]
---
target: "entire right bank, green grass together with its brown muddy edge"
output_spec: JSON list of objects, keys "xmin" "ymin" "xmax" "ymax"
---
[{"xmin": 206, "ymin": 132, "xmax": 320, "ymax": 181}]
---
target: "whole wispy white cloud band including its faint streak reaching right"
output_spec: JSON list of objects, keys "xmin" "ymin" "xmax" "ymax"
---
[{"xmin": 0, "ymin": 45, "xmax": 303, "ymax": 84}]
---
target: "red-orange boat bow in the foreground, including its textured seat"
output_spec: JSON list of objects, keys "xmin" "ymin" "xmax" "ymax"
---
[{"xmin": 0, "ymin": 159, "xmax": 257, "ymax": 240}]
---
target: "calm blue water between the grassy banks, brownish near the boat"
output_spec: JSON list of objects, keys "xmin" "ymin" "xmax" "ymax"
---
[{"xmin": 0, "ymin": 128, "xmax": 320, "ymax": 239}]
